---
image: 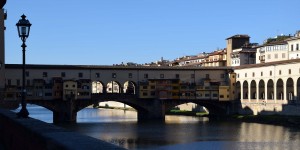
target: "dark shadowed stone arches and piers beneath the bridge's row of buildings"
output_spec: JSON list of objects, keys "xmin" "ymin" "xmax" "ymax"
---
[{"xmin": 27, "ymin": 93, "xmax": 234, "ymax": 123}]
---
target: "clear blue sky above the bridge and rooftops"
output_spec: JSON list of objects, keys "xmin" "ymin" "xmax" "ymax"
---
[{"xmin": 4, "ymin": 0, "xmax": 300, "ymax": 65}]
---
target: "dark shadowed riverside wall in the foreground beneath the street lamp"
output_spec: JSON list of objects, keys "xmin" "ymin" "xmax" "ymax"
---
[{"xmin": 0, "ymin": 109, "xmax": 123, "ymax": 150}]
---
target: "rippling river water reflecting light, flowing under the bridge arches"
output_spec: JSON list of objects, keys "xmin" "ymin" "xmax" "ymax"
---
[{"xmin": 17, "ymin": 105, "xmax": 300, "ymax": 150}]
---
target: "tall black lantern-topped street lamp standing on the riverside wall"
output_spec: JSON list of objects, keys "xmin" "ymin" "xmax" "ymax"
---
[{"xmin": 16, "ymin": 14, "xmax": 31, "ymax": 118}]
